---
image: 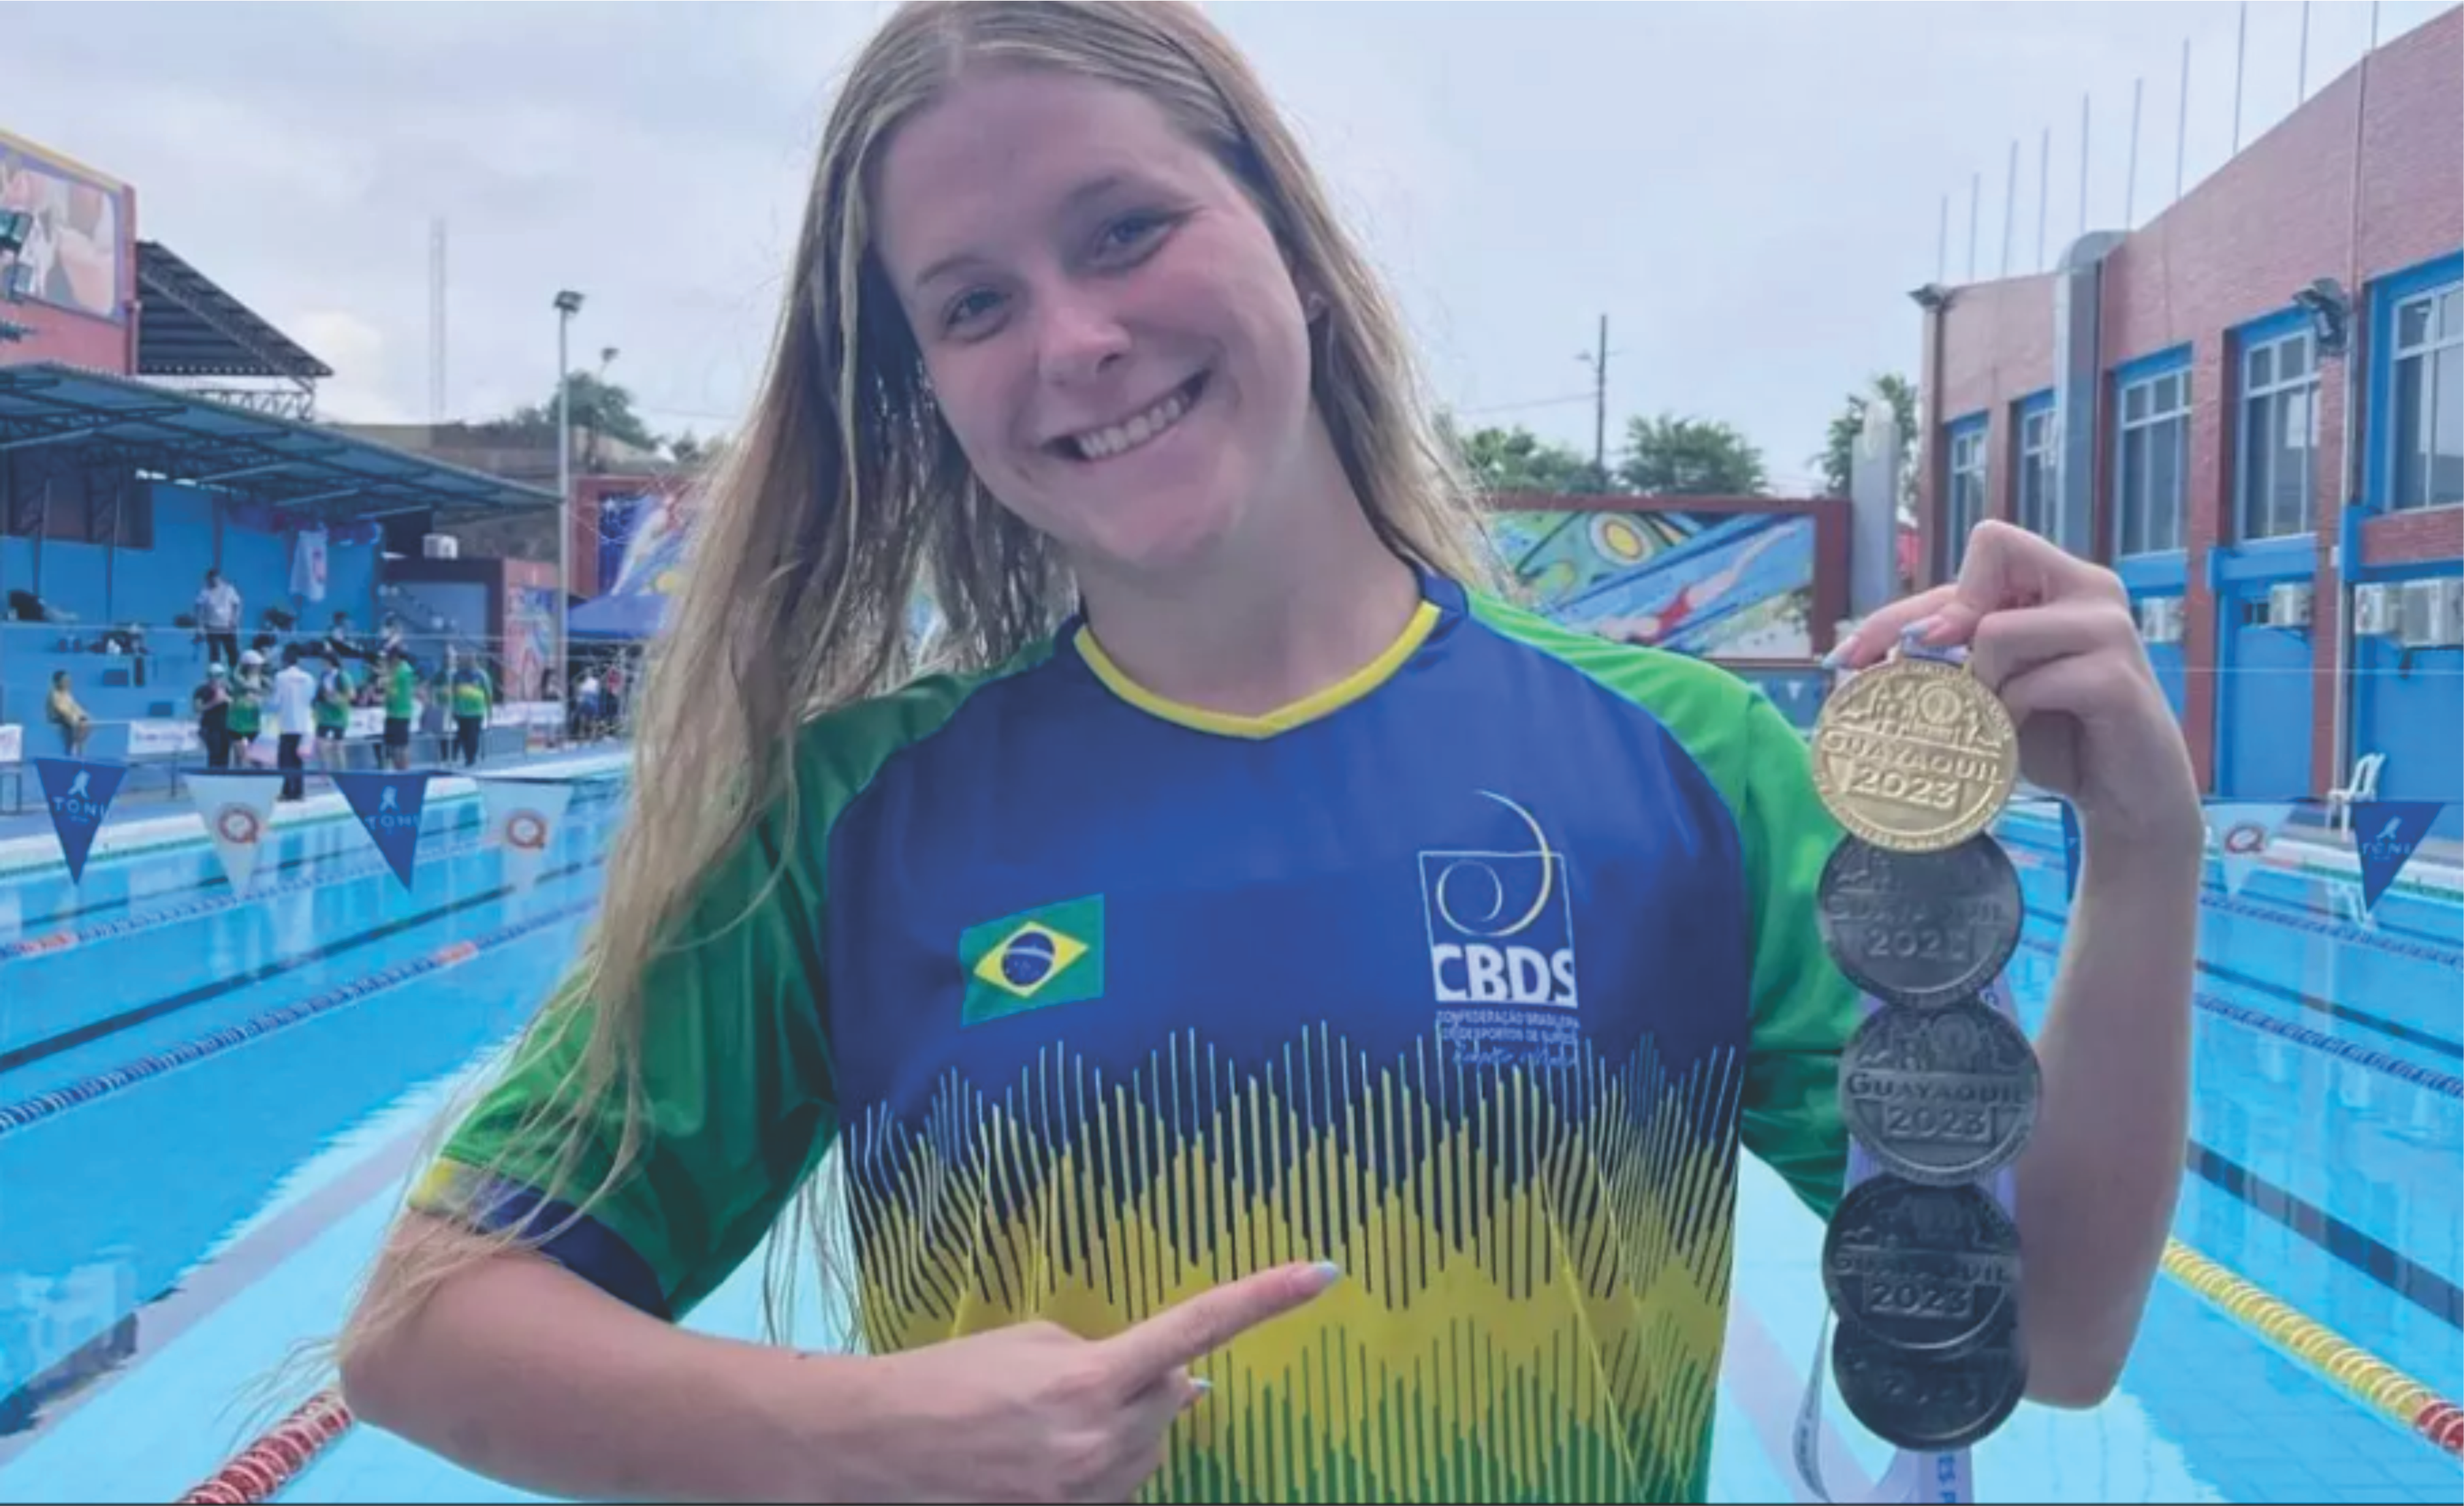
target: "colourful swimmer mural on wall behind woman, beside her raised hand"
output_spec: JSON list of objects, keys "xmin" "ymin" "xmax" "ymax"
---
[{"xmin": 1493, "ymin": 510, "xmax": 1814, "ymax": 658}]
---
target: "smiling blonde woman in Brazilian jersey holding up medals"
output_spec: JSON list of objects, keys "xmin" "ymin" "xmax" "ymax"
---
[{"xmin": 343, "ymin": 5, "xmax": 2200, "ymax": 1501}]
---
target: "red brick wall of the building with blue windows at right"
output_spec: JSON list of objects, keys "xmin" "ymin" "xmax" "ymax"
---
[{"xmin": 1919, "ymin": 10, "xmax": 2464, "ymax": 789}]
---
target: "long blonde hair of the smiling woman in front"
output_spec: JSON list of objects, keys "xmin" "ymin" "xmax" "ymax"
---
[{"xmin": 340, "ymin": 0, "xmax": 1498, "ymax": 1390}]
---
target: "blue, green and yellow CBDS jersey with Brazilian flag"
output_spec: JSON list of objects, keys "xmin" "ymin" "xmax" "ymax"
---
[{"xmin": 417, "ymin": 579, "xmax": 1858, "ymax": 1501}]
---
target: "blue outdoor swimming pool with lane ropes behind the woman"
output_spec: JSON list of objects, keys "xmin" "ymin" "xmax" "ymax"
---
[{"xmin": 0, "ymin": 772, "xmax": 2464, "ymax": 1501}]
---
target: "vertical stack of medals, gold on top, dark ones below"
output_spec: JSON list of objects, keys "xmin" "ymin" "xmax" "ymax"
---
[{"xmin": 1814, "ymin": 653, "xmax": 2038, "ymax": 1454}]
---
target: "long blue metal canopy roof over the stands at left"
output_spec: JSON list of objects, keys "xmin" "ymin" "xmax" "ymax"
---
[{"xmin": 0, "ymin": 362, "xmax": 557, "ymax": 520}]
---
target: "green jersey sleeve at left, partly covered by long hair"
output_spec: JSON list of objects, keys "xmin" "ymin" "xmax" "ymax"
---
[{"xmin": 417, "ymin": 779, "xmax": 835, "ymax": 1316}]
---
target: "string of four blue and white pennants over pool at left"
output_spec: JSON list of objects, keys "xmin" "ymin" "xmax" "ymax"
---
[{"xmin": 29, "ymin": 759, "xmax": 572, "ymax": 892}]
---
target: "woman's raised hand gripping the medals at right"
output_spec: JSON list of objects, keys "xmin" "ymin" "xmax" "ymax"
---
[{"xmin": 1826, "ymin": 520, "xmax": 2205, "ymax": 853}]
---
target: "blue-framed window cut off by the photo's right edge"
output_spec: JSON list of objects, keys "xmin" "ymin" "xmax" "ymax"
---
[{"xmin": 2368, "ymin": 254, "xmax": 2464, "ymax": 512}]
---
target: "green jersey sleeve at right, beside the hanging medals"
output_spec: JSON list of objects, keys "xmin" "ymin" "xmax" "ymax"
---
[{"xmin": 1730, "ymin": 687, "xmax": 1858, "ymax": 1217}]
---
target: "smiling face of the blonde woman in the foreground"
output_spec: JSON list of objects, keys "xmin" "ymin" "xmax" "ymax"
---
[{"xmin": 875, "ymin": 69, "xmax": 1311, "ymax": 589}]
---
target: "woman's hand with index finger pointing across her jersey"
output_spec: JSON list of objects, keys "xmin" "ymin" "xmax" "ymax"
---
[{"xmin": 815, "ymin": 1264, "xmax": 1338, "ymax": 1501}]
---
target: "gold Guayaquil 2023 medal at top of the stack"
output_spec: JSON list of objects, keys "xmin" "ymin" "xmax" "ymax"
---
[{"xmin": 1814, "ymin": 655, "xmax": 2018, "ymax": 853}]
